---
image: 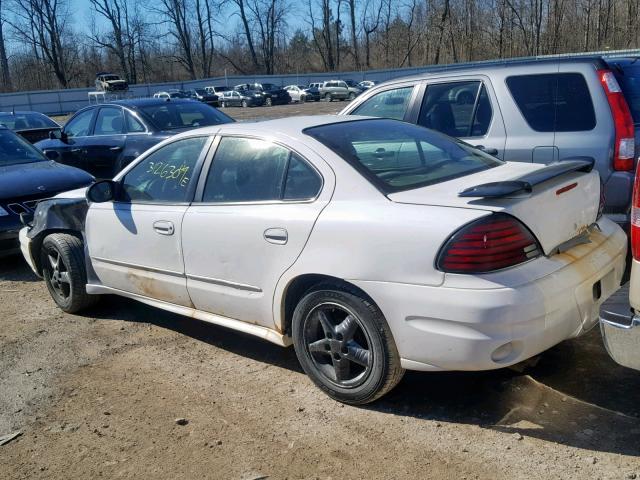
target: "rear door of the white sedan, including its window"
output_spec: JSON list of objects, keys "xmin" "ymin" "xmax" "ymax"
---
[{"xmin": 182, "ymin": 136, "xmax": 334, "ymax": 328}]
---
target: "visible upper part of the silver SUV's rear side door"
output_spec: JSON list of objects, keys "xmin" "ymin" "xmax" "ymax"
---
[{"xmin": 417, "ymin": 77, "xmax": 506, "ymax": 158}]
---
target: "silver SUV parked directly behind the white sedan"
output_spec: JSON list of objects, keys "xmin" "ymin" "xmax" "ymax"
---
[{"xmin": 340, "ymin": 57, "xmax": 640, "ymax": 228}]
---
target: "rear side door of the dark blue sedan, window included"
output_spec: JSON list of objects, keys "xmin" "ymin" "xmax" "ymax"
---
[{"xmin": 85, "ymin": 106, "xmax": 127, "ymax": 178}]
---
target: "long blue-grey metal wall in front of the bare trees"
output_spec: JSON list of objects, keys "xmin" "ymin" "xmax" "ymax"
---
[{"xmin": 0, "ymin": 49, "xmax": 640, "ymax": 115}]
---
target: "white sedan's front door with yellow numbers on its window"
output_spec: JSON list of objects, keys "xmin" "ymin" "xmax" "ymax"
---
[{"xmin": 85, "ymin": 135, "xmax": 211, "ymax": 306}]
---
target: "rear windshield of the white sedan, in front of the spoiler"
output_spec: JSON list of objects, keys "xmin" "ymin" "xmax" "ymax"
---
[{"xmin": 304, "ymin": 119, "xmax": 503, "ymax": 193}]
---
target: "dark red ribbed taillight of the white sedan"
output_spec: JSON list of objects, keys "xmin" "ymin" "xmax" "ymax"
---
[{"xmin": 437, "ymin": 213, "xmax": 541, "ymax": 273}]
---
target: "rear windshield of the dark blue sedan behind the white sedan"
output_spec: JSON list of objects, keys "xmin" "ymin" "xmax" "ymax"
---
[{"xmin": 139, "ymin": 102, "xmax": 233, "ymax": 130}]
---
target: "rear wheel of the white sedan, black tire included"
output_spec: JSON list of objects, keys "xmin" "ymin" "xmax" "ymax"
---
[{"xmin": 292, "ymin": 285, "xmax": 404, "ymax": 405}]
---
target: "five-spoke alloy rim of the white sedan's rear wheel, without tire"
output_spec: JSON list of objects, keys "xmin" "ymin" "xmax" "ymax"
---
[{"xmin": 303, "ymin": 303, "xmax": 373, "ymax": 388}]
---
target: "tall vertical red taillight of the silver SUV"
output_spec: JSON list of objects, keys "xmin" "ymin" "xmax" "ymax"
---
[{"xmin": 598, "ymin": 70, "xmax": 636, "ymax": 171}]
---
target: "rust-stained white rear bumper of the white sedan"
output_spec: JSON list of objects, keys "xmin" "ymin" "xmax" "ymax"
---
[{"xmin": 353, "ymin": 219, "xmax": 627, "ymax": 370}]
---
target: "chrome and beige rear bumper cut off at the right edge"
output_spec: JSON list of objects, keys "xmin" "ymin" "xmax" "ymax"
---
[{"xmin": 600, "ymin": 260, "xmax": 640, "ymax": 370}]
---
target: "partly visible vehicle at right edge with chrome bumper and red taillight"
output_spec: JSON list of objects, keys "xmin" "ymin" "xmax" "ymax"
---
[{"xmin": 600, "ymin": 158, "xmax": 640, "ymax": 370}]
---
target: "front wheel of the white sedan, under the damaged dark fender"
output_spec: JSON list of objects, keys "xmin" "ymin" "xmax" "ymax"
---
[{"xmin": 40, "ymin": 233, "xmax": 98, "ymax": 313}]
